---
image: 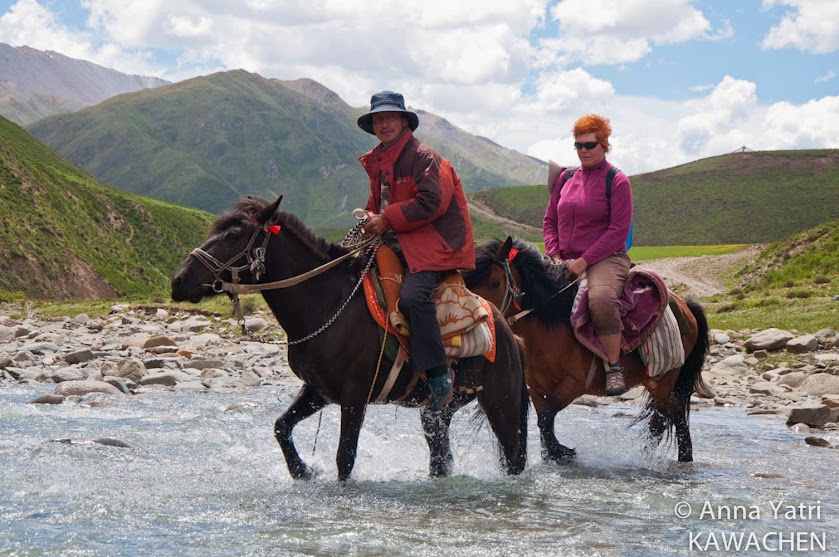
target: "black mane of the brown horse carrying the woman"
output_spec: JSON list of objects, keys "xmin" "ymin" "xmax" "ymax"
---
[{"xmin": 464, "ymin": 238, "xmax": 577, "ymax": 327}]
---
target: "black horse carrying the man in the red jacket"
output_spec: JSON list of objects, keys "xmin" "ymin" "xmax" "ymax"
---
[{"xmin": 172, "ymin": 196, "xmax": 529, "ymax": 480}]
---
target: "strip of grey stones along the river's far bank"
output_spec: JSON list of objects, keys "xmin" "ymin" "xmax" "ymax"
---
[{"xmin": 0, "ymin": 304, "xmax": 839, "ymax": 446}]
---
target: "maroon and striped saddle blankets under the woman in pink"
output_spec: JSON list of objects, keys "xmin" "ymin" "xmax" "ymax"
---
[{"xmin": 571, "ymin": 267, "xmax": 690, "ymax": 379}]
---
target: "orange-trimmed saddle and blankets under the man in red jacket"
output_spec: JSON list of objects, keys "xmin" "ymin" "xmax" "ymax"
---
[{"xmin": 364, "ymin": 245, "xmax": 495, "ymax": 362}]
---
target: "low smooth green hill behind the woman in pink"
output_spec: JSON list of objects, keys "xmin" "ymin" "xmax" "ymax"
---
[{"xmin": 474, "ymin": 149, "xmax": 839, "ymax": 246}]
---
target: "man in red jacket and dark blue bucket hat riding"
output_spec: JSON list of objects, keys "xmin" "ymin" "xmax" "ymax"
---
[{"xmin": 358, "ymin": 91, "xmax": 475, "ymax": 409}]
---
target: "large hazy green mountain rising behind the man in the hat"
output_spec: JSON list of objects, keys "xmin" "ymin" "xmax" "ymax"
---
[{"xmin": 29, "ymin": 70, "xmax": 543, "ymax": 228}]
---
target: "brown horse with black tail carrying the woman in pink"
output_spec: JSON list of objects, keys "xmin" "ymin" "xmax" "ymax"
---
[{"xmin": 463, "ymin": 237, "xmax": 709, "ymax": 462}]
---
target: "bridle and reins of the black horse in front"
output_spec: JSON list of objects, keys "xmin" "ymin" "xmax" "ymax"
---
[{"xmin": 189, "ymin": 217, "xmax": 382, "ymax": 346}]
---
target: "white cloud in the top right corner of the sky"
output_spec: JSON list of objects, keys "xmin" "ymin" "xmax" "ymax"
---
[{"xmin": 762, "ymin": 0, "xmax": 839, "ymax": 54}]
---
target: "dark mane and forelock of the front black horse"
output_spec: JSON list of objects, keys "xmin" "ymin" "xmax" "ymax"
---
[{"xmin": 215, "ymin": 196, "xmax": 349, "ymax": 261}]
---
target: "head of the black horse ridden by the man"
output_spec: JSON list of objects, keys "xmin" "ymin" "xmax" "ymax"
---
[{"xmin": 172, "ymin": 196, "xmax": 283, "ymax": 303}]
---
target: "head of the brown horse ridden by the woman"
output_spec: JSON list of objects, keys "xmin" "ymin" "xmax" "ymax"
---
[{"xmin": 463, "ymin": 236, "xmax": 523, "ymax": 315}]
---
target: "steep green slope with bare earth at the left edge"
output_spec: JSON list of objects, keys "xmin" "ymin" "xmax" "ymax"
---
[{"xmin": 0, "ymin": 114, "xmax": 212, "ymax": 299}]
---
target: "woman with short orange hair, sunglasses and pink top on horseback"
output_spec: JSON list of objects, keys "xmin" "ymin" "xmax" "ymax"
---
[{"xmin": 542, "ymin": 114, "xmax": 632, "ymax": 396}]
